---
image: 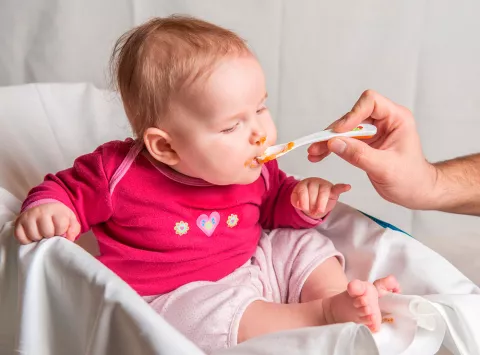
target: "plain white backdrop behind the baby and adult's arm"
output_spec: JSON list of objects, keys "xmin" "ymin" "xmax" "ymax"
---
[{"xmin": 0, "ymin": 0, "xmax": 480, "ymax": 282}]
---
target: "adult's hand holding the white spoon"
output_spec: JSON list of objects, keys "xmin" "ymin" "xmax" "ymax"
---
[{"xmin": 308, "ymin": 90, "xmax": 438, "ymax": 209}]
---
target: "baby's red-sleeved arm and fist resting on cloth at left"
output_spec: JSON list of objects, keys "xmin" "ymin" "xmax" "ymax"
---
[{"xmin": 15, "ymin": 147, "xmax": 112, "ymax": 244}]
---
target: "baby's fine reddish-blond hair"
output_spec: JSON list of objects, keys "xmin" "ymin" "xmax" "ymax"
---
[{"xmin": 110, "ymin": 16, "xmax": 251, "ymax": 138}]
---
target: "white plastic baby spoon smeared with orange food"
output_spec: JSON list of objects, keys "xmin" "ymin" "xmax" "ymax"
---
[{"xmin": 256, "ymin": 124, "xmax": 377, "ymax": 164}]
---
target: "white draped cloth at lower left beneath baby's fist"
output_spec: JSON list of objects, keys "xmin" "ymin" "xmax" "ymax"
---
[{"xmin": 0, "ymin": 189, "xmax": 202, "ymax": 355}]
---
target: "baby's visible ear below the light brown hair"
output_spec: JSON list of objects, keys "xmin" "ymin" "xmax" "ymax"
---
[{"xmin": 143, "ymin": 127, "xmax": 180, "ymax": 166}]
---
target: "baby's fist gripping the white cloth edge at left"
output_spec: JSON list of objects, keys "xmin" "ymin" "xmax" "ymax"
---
[{"xmin": 15, "ymin": 202, "xmax": 80, "ymax": 244}]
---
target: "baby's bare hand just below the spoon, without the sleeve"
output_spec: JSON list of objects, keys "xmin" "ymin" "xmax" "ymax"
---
[{"xmin": 291, "ymin": 178, "xmax": 350, "ymax": 219}]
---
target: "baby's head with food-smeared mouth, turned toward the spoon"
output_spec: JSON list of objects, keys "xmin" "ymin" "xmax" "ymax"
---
[{"xmin": 112, "ymin": 17, "xmax": 276, "ymax": 185}]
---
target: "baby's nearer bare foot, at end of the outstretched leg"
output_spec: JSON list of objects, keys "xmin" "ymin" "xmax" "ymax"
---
[{"xmin": 323, "ymin": 280, "xmax": 382, "ymax": 332}]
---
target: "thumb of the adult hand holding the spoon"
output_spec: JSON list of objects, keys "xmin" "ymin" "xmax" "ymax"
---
[{"xmin": 328, "ymin": 137, "xmax": 384, "ymax": 175}]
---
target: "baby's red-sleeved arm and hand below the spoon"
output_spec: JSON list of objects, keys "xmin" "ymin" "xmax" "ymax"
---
[{"xmin": 260, "ymin": 161, "xmax": 350, "ymax": 229}]
